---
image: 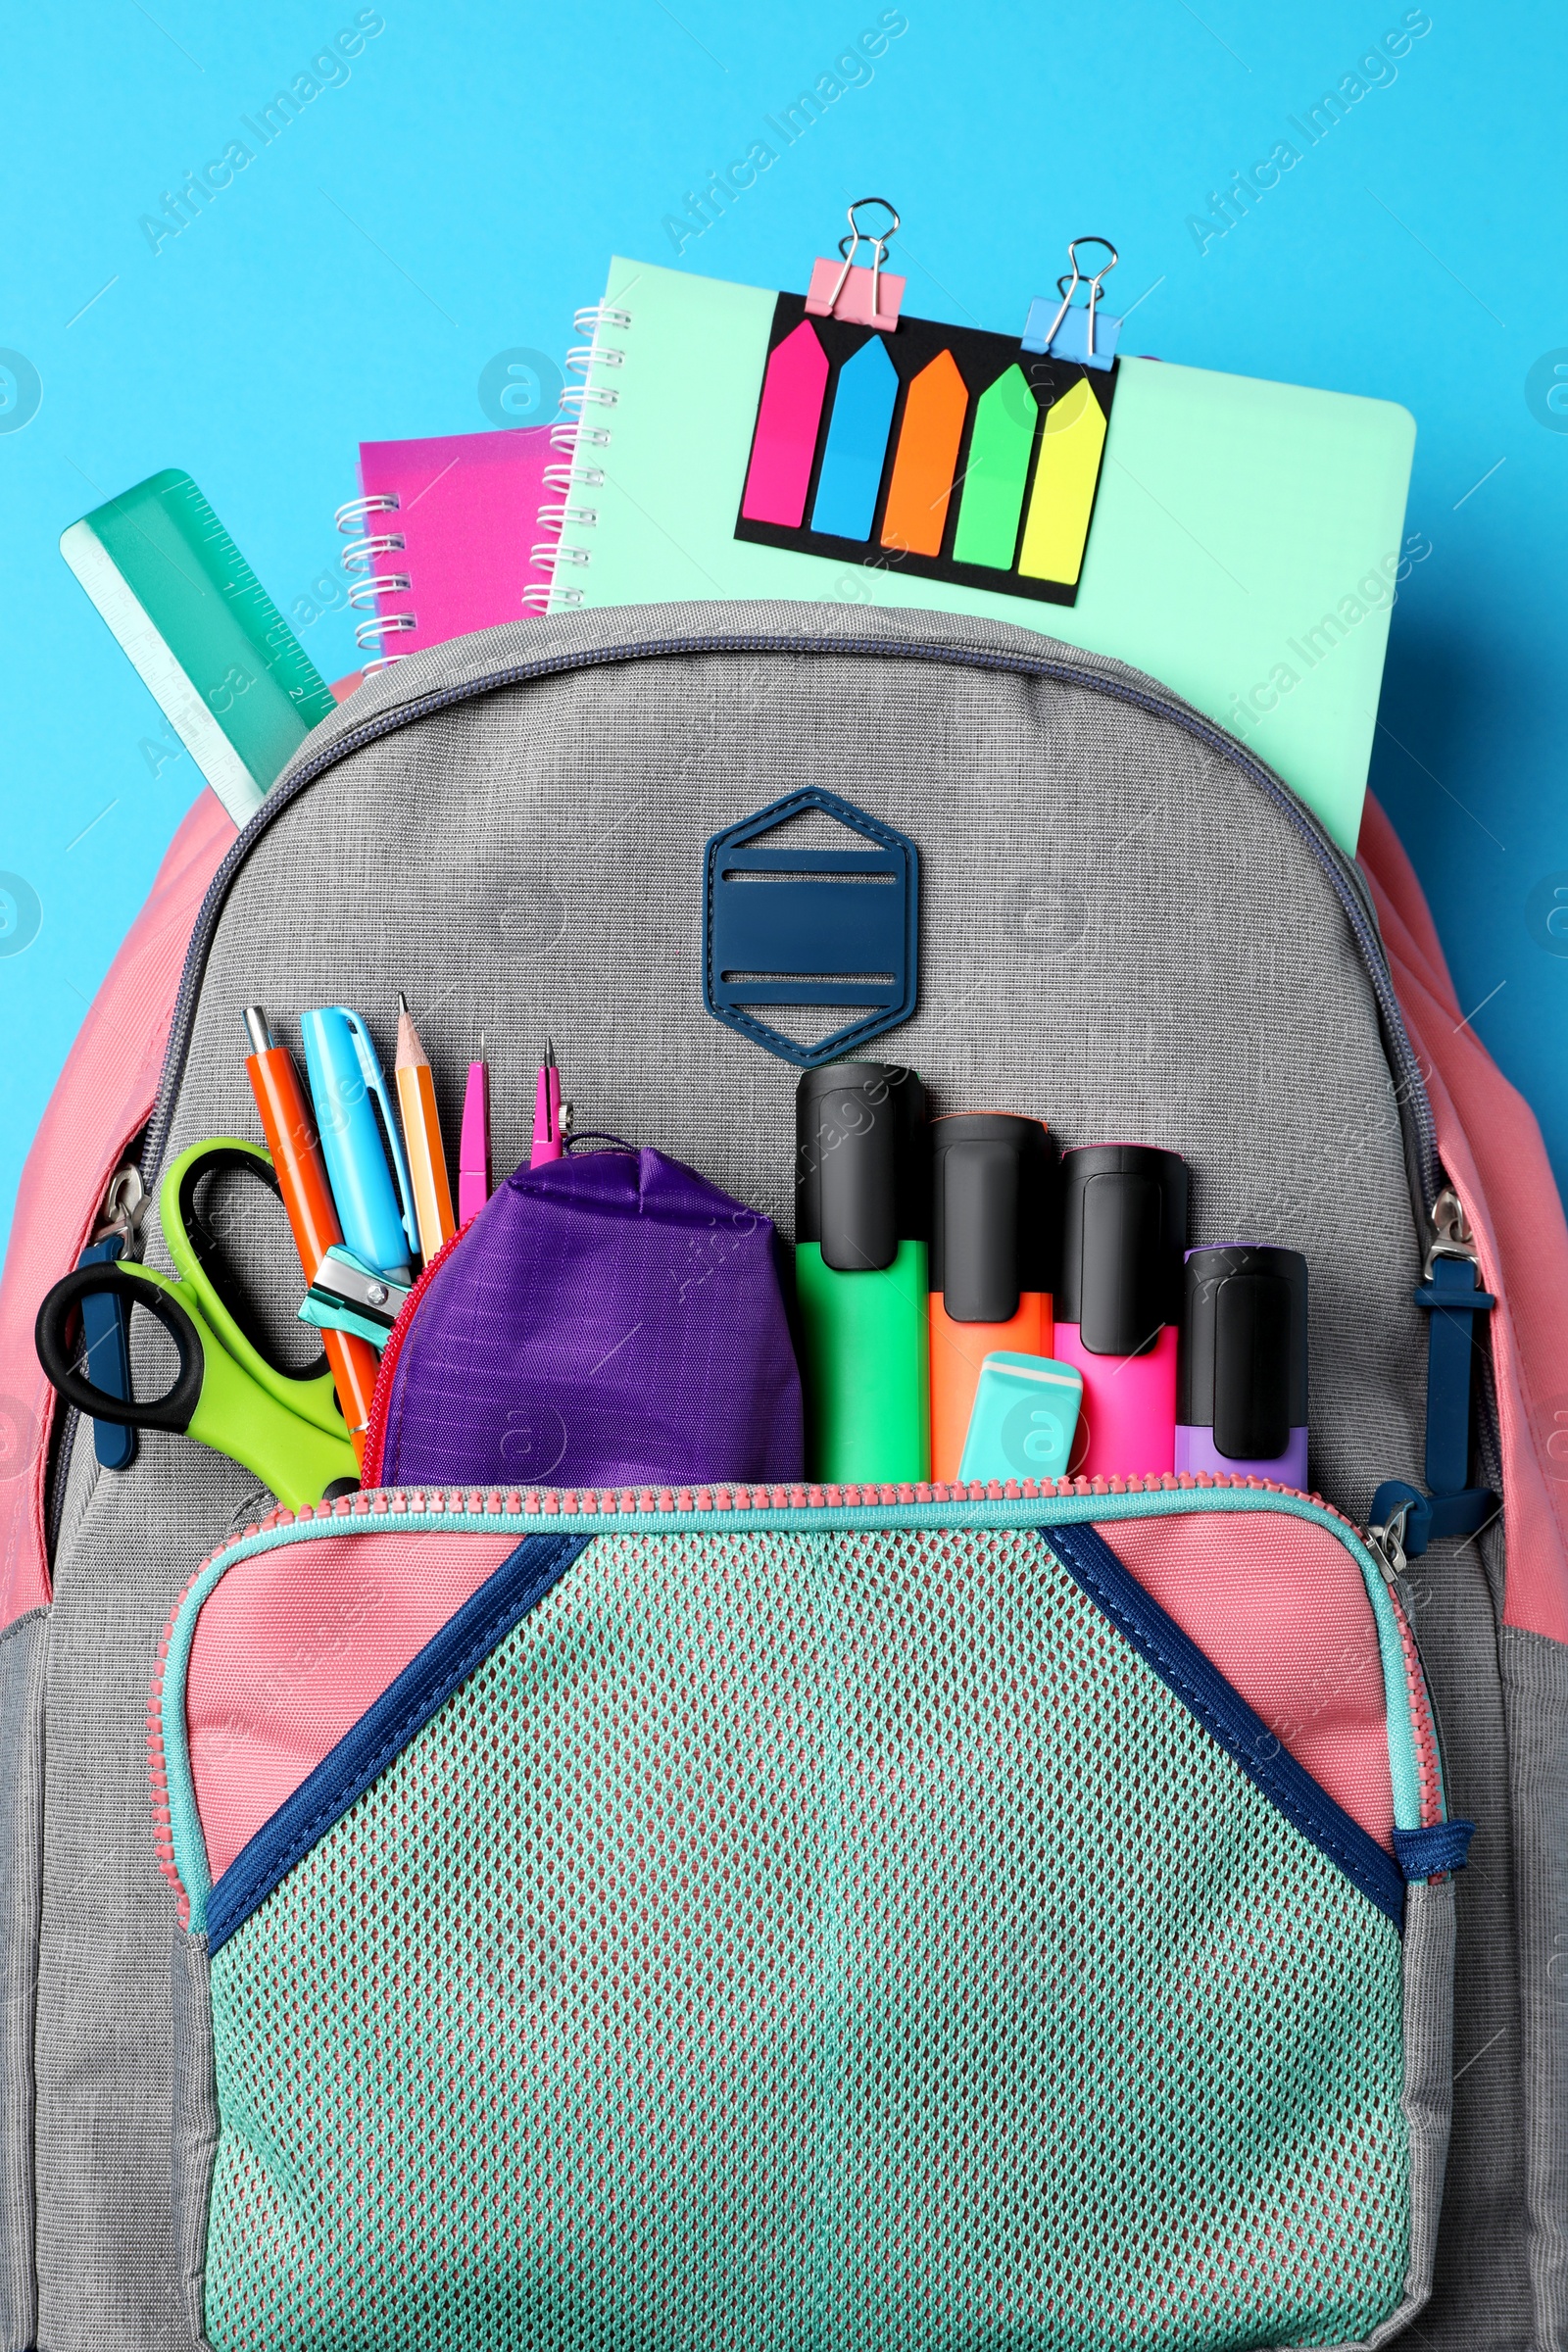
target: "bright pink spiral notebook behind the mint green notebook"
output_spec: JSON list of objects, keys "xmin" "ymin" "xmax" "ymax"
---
[{"xmin": 338, "ymin": 425, "xmax": 562, "ymax": 668}]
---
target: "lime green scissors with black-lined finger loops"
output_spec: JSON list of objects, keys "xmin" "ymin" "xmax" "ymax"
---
[{"xmin": 35, "ymin": 1136, "xmax": 360, "ymax": 1510}]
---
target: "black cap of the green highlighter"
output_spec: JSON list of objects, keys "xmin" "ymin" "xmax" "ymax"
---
[{"xmin": 795, "ymin": 1060, "xmax": 931, "ymax": 1275}]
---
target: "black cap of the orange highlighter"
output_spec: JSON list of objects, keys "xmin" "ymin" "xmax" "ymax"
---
[{"xmin": 931, "ymin": 1110, "xmax": 1057, "ymax": 1322}]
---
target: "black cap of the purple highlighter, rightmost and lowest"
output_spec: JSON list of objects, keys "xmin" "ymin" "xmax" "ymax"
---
[{"xmin": 1175, "ymin": 1242, "xmax": 1307, "ymax": 1463}]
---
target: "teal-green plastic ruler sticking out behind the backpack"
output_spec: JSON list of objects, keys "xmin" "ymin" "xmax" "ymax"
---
[{"xmin": 59, "ymin": 468, "xmax": 334, "ymax": 825}]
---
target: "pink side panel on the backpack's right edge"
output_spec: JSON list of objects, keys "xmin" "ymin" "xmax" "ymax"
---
[{"xmin": 1359, "ymin": 795, "xmax": 1568, "ymax": 1642}]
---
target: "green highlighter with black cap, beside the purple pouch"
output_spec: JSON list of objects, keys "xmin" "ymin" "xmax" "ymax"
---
[{"xmin": 795, "ymin": 1060, "xmax": 931, "ymax": 1487}]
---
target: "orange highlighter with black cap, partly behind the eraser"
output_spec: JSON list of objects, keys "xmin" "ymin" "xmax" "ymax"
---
[{"xmin": 931, "ymin": 1110, "xmax": 1060, "ymax": 1480}]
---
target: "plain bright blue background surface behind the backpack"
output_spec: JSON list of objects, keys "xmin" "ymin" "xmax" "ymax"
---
[{"xmin": 0, "ymin": 0, "xmax": 1568, "ymax": 1250}]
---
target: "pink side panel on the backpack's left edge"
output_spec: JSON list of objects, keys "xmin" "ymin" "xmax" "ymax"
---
[{"xmin": 0, "ymin": 790, "xmax": 237, "ymax": 1625}]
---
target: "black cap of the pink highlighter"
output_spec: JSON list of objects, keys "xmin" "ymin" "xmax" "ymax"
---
[{"xmin": 1055, "ymin": 1143, "xmax": 1187, "ymax": 1354}]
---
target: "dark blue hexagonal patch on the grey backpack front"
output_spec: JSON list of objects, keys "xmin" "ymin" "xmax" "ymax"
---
[{"xmin": 703, "ymin": 786, "xmax": 919, "ymax": 1070}]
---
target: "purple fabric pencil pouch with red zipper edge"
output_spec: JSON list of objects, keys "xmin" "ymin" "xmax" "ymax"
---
[{"xmin": 365, "ymin": 1151, "xmax": 804, "ymax": 1487}]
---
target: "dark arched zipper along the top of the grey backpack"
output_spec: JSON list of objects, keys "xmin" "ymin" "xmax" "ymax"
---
[{"xmin": 141, "ymin": 633, "xmax": 1444, "ymax": 1247}]
